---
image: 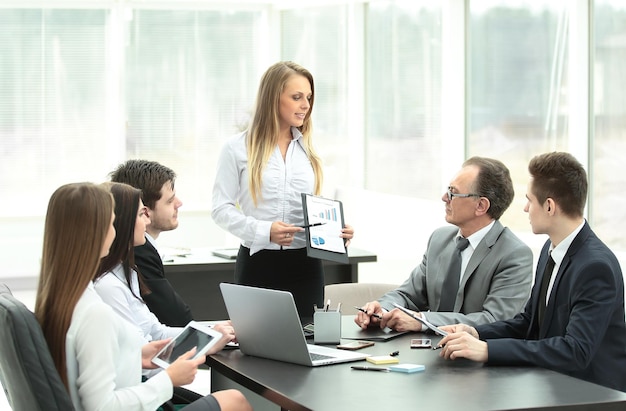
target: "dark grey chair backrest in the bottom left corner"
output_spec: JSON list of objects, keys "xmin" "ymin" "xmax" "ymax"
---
[{"xmin": 0, "ymin": 284, "xmax": 74, "ymax": 411}]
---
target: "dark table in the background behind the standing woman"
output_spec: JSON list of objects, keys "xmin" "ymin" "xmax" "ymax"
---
[{"xmin": 163, "ymin": 247, "xmax": 377, "ymax": 321}]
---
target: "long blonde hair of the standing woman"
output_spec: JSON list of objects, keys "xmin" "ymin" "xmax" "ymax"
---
[{"xmin": 246, "ymin": 61, "xmax": 323, "ymax": 205}]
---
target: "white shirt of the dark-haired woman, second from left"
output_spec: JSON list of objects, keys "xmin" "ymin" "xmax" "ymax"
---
[{"xmin": 94, "ymin": 264, "xmax": 182, "ymax": 342}]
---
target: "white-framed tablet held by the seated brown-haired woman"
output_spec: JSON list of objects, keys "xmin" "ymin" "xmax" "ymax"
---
[{"xmin": 152, "ymin": 321, "xmax": 222, "ymax": 368}]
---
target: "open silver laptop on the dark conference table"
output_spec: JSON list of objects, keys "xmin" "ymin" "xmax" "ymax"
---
[{"xmin": 220, "ymin": 283, "xmax": 368, "ymax": 367}]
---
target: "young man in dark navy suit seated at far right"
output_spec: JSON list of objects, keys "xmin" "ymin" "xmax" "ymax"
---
[{"xmin": 440, "ymin": 152, "xmax": 626, "ymax": 391}]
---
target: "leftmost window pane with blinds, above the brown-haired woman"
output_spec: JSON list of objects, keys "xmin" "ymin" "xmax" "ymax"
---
[{"xmin": 0, "ymin": 8, "xmax": 110, "ymax": 217}]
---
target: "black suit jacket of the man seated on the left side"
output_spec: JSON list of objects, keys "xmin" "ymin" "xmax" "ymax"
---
[{"xmin": 135, "ymin": 240, "xmax": 193, "ymax": 327}]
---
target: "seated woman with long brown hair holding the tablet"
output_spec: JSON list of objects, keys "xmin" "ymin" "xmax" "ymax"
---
[{"xmin": 35, "ymin": 183, "xmax": 251, "ymax": 411}]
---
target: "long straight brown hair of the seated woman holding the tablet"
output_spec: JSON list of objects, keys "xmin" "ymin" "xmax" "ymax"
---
[{"xmin": 35, "ymin": 183, "xmax": 113, "ymax": 388}]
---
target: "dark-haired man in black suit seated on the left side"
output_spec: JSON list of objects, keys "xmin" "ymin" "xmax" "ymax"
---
[{"xmin": 110, "ymin": 160, "xmax": 192, "ymax": 327}]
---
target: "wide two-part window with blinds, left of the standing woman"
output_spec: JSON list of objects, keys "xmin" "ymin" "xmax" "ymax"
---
[{"xmin": 0, "ymin": 9, "xmax": 267, "ymax": 216}]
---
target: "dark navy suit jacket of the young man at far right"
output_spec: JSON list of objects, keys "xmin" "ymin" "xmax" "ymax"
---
[{"xmin": 476, "ymin": 223, "xmax": 626, "ymax": 391}]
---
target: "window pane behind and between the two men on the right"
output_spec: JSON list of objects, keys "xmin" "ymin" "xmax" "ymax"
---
[{"xmin": 467, "ymin": 0, "xmax": 569, "ymax": 231}]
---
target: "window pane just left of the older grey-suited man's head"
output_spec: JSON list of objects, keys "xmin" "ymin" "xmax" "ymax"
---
[{"xmin": 364, "ymin": 1, "xmax": 443, "ymax": 199}]
